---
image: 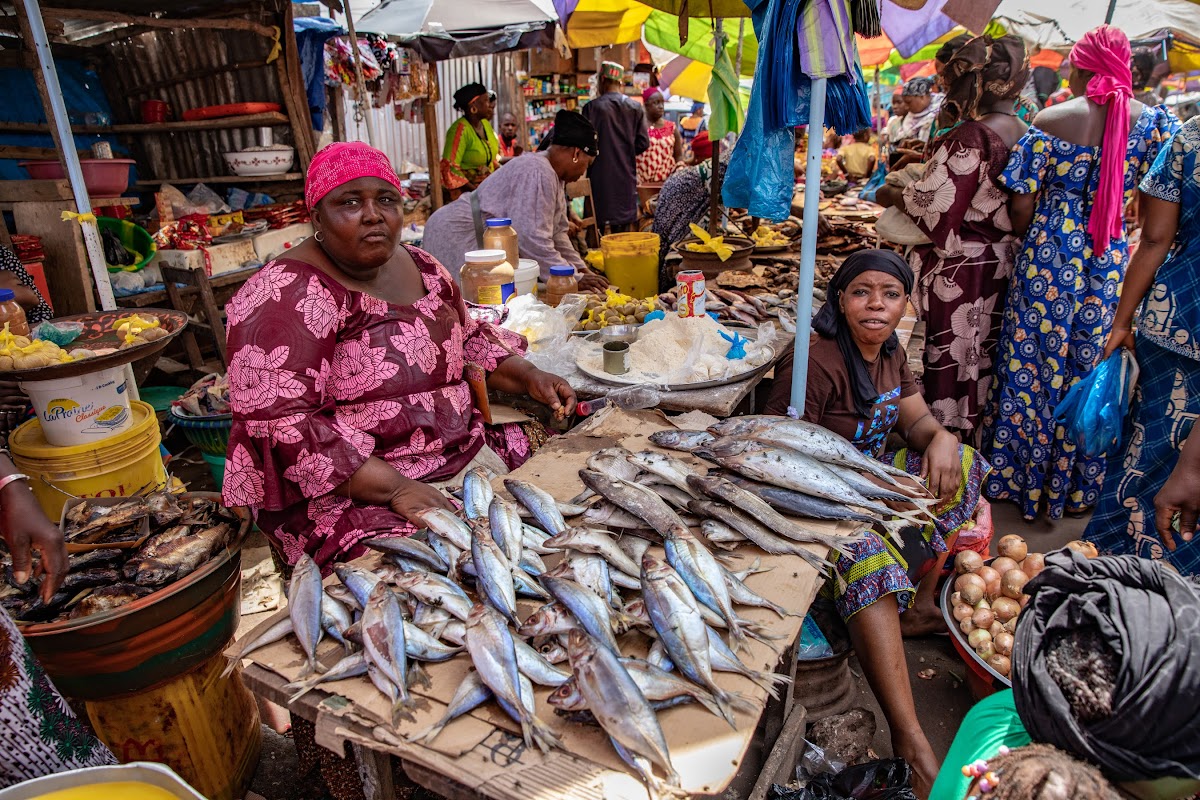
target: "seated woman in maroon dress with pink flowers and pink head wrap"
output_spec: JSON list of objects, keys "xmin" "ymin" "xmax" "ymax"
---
[{"xmin": 224, "ymin": 143, "xmax": 575, "ymax": 573}]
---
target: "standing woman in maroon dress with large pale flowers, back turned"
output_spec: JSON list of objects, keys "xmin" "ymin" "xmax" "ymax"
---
[{"xmin": 876, "ymin": 36, "xmax": 1028, "ymax": 441}]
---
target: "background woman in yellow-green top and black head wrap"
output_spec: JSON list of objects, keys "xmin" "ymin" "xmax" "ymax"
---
[{"xmin": 442, "ymin": 83, "xmax": 500, "ymax": 200}]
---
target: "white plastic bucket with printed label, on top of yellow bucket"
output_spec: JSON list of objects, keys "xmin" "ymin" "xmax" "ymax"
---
[{"xmin": 20, "ymin": 367, "xmax": 133, "ymax": 447}]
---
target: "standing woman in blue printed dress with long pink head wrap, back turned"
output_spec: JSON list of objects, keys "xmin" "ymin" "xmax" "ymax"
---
[{"xmin": 982, "ymin": 25, "xmax": 1178, "ymax": 519}]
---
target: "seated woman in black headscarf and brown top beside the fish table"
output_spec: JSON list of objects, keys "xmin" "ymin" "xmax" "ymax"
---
[{"xmin": 766, "ymin": 249, "xmax": 985, "ymax": 796}]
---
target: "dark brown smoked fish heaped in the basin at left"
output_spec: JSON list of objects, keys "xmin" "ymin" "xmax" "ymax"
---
[{"xmin": 0, "ymin": 492, "xmax": 240, "ymax": 622}]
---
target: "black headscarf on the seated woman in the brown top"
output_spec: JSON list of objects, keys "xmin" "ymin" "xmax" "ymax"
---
[{"xmin": 812, "ymin": 249, "xmax": 913, "ymax": 416}]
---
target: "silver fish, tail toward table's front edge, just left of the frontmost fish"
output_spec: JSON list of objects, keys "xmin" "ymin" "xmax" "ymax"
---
[{"xmin": 467, "ymin": 603, "xmax": 562, "ymax": 752}]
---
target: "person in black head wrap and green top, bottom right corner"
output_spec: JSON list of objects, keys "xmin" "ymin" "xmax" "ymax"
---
[{"xmin": 930, "ymin": 549, "xmax": 1200, "ymax": 800}]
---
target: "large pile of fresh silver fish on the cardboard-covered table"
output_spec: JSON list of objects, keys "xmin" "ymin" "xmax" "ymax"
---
[{"xmin": 229, "ymin": 417, "xmax": 928, "ymax": 798}]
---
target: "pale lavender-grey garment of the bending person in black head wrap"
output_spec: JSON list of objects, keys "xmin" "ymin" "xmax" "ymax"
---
[{"xmin": 421, "ymin": 152, "xmax": 584, "ymax": 281}]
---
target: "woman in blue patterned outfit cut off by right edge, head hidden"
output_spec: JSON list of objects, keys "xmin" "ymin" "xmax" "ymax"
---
[{"xmin": 1085, "ymin": 118, "xmax": 1200, "ymax": 575}]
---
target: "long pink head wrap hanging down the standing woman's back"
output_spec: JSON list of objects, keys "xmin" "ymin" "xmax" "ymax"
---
[{"xmin": 1070, "ymin": 25, "xmax": 1133, "ymax": 253}]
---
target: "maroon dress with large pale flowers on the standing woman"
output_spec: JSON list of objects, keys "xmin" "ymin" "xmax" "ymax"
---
[{"xmin": 904, "ymin": 120, "xmax": 1016, "ymax": 434}]
